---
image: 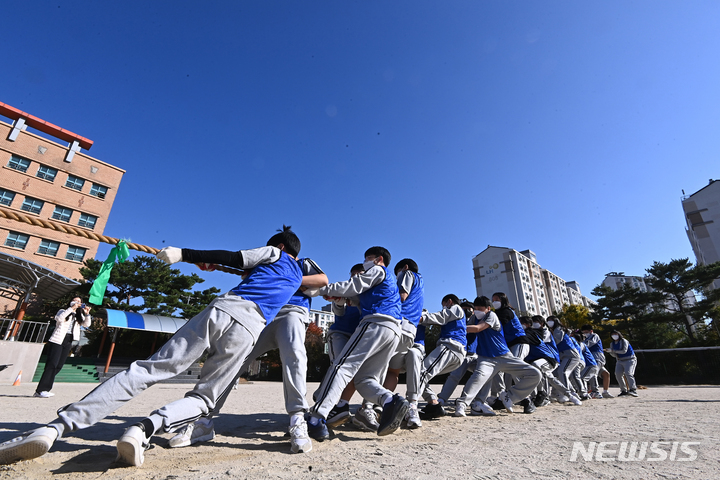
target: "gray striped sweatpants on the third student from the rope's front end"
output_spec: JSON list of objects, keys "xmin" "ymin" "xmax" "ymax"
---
[{"xmin": 312, "ymin": 319, "xmax": 399, "ymax": 418}]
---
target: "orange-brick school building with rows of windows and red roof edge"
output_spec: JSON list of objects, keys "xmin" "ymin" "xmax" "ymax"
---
[{"xmin": 0, "ymin": 103, "xmax": 125, "ymax": 279}]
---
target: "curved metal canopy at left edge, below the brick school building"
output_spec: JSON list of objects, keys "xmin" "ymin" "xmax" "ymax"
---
[{"xmin": 0, "ymin": 252, "xmax": 80, "ymax": 314}]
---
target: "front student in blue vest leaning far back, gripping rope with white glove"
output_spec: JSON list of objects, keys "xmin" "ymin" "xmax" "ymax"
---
[{"xmin": 0, "ymin": 227, "xmax": 302, "ymax": 466}]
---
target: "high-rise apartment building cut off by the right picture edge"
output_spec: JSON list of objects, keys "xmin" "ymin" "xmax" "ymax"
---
[{"xmin": 682, "ymin": 179, "xmax": 720, "ymax": 288}]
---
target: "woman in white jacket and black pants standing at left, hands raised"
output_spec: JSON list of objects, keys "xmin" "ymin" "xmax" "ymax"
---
[{"xmin": 34, "ymin": 297, "xmax": 92, "ymax": 398}]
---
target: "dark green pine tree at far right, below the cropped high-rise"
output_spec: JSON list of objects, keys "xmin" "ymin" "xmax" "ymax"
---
[{"xmin": 639, "ymin": 258, "xmax": 720, "ymax": 346}]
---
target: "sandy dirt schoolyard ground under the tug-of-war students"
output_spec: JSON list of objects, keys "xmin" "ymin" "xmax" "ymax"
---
[{"xmin": 0, "ymin": 383, "xmax": 720, "ymax": 480}]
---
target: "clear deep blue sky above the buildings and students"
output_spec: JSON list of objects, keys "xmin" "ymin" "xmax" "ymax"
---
[{"xmin": 0, "ymin": 0, "xmax": 720, "ymax": 309}]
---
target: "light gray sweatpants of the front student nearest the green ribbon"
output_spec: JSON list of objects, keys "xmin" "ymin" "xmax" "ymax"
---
[{"xmin": 53, "ymin": 304, "xmax": 265, "ymax": 432}]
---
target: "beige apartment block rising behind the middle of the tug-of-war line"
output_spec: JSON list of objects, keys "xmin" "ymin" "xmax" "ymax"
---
[{"xmin": 473, "ymin": 245, "xmax": 595, "ymax": 317}]
